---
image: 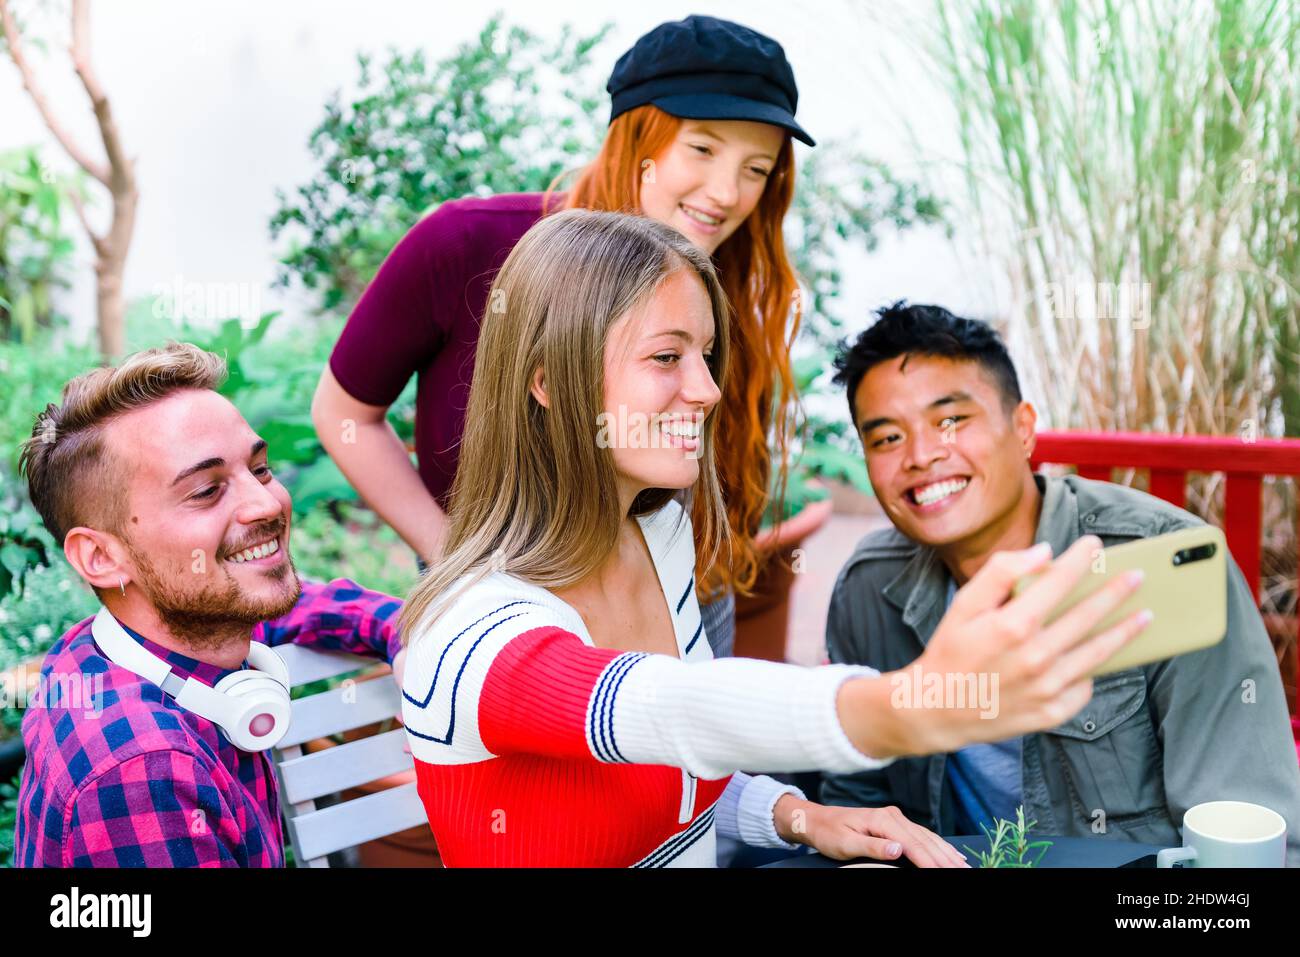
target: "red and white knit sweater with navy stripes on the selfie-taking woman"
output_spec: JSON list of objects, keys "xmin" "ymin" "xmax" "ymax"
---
[{"xmin": 403, "ymin": 502, "xmax": 888, "ymax": 867}]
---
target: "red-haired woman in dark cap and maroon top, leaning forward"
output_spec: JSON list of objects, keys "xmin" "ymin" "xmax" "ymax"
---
[{"xmin": 312, "ymin": 17, "xmax": 813, "ymax": 655}]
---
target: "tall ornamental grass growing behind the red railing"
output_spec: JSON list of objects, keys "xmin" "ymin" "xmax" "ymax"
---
[{"xmin": 924, "ymin": 0, "xmax": 1300, "ymax": 624}]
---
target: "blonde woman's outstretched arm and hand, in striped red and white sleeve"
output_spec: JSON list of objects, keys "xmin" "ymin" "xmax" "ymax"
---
[{"xmin": 403, "ymin": 537, "xmax": 1145, "ymax": 778}]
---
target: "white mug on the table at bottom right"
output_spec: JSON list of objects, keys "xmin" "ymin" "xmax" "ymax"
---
[{"xmin": 1156, "ymin": 801, "xmax": 1287, "ymax": 867}]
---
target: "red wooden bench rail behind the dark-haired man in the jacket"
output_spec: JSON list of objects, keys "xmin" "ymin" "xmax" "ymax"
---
[{"xmin": 1032, "ymin": 432, "xmax": 1300, "ymax": 740}]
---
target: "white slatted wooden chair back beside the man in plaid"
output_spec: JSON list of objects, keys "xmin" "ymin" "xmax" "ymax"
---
[{"xmin": 272, "ymin": 645, "xmax": 428, "ymax": 867}]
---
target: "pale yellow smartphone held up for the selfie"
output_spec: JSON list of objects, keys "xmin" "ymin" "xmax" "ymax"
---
[{"xmin": 1014, "ymin": 525, "xmax": 1227, "ymax": 677}]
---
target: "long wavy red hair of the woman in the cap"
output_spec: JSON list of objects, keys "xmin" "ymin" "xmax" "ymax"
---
[{"xmin": 546, "ymin": 104, "xmax": 801, "ymax": 598}]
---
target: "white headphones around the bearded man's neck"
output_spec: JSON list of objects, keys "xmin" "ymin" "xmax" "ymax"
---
[{"xmin": 91, "ymin": 607, "xmax": 290, "ymax": 752}]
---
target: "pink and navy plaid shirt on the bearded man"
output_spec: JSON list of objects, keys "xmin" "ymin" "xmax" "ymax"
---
[{"xmin": 13, "ymin": 579, "xmax": 402, "ymax": 867}]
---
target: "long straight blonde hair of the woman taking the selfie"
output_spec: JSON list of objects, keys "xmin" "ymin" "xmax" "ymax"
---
[{"xmin": 400, "ymin": 209, "xmax": 729, "ymax": 642}]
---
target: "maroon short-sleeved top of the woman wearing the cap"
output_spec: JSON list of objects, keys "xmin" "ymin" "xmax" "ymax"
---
[{"xmin": 329, "ymin": 192, "xmax": 553, "ymax": 508}]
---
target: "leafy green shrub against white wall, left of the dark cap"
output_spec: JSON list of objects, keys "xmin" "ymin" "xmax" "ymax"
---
[{"xmin": 270, "ymin": 16, "xmax": 608, "ymax": 312}]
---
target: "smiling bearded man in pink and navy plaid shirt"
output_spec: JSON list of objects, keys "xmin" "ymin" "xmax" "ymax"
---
[{"xmin": 13, "ymin": 345, "xmax": 400, "ymax": 867}]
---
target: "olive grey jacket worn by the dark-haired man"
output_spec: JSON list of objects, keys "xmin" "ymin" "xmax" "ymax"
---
[{"xmin": 822, "ymin": 475, "xmax": 1300, "ymax": 866}]
